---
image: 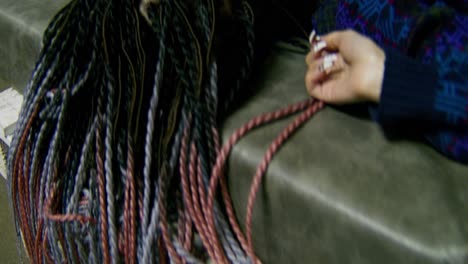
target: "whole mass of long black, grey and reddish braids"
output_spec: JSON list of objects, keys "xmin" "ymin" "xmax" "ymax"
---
[{"xmin": 7, "ymin": 0, "xmax": 322, "ymax": 263}]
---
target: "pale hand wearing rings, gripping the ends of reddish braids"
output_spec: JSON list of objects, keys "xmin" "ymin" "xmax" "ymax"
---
[{"xmin": 305, "ymin": 30, "xmax": 385, "ymax": 104}]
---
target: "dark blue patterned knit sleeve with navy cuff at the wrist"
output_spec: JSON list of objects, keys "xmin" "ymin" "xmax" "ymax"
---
[{"xmin": 376, "ymin": 15, "xmax": 468, "ymax": 163}]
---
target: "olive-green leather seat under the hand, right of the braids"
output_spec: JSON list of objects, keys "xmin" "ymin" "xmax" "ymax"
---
[{"xmin": 223, "ymin": 46, "xmax": 468, "ymax": 264}]
